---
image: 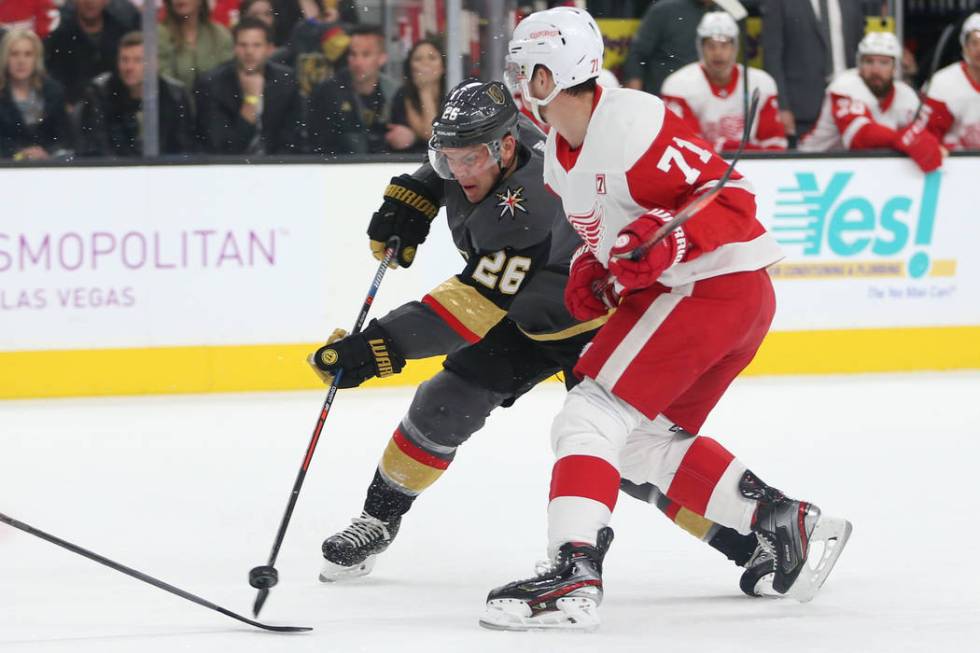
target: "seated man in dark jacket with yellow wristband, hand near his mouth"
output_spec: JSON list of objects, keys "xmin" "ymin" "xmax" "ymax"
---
[{"xmin": 191, "ymin": 18, "xmax": 302, "ymax": 154}]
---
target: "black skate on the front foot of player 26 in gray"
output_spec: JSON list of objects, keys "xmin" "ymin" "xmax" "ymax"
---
[{"xmin": 320, "ymin": 512, "xmax": 401, "ymax": 583}]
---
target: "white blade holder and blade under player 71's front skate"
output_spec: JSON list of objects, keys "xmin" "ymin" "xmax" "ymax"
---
[{"xmin": 480, "ymin": 596, "xmax": 599, "ymax": 632}]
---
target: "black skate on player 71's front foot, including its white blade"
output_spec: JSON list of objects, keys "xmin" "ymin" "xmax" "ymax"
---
[{"xmin": 480, "ymin": 526, "xmax": 613, "ymax": 630}]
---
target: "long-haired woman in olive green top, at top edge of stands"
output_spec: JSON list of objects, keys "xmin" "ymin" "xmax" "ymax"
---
[{"xmin": 158, "ymin": 0, "xmax": 232, "ymax": 88}]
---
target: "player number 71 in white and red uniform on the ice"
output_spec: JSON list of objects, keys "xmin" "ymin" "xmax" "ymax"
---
[{"xmin": 480, "ymin": 7, "xmax": 850, "ymax": 630}]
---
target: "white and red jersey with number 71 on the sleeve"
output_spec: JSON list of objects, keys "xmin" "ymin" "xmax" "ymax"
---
[{"xmin": 544, "ymin": 88, "xmax": 783, "ymax": 287}]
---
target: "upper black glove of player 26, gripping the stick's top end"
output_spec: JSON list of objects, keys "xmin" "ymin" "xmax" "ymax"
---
[{"xmin": 368, "ymin": 175, "xmax": 439, "ymax": 268}]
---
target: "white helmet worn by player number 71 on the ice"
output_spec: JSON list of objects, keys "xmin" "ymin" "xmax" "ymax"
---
[{"xmin": 504, "ymin": 7, "xmax": 604, "ymax": 120}]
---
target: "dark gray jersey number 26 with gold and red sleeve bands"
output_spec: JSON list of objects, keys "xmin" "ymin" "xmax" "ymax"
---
[{"xmin": 379, "ymin": 116, "xmax": 598, "ymax": 358}]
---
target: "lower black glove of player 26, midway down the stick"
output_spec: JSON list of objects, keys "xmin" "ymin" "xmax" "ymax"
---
[{"xmin": 306, "ymin": 320, "xmax": 405, "ymax": 388}]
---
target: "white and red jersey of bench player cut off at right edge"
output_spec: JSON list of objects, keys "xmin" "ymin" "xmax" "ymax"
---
[{"xmin": 923, "ymin": 61, "xmax": 980, "ymax": 150}]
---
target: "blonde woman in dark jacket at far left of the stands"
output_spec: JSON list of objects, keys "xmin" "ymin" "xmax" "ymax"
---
[{"xmin": 0, "ymin": 29, "xmax": 72, "ymax": 160}]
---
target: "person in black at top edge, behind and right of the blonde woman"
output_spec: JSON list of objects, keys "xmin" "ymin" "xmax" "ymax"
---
[{"xmin": 44, "ymin": 0, "xmax": 129, "ymax": 105}]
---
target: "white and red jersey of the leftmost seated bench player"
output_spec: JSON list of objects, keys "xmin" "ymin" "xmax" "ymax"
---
[{"xmin": 660, "ymin": 63, "xmax": 787, "ymax": 152}]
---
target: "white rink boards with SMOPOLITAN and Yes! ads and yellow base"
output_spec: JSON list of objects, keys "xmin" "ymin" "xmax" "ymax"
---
[{"xmin": 0, "ymin": 157, "xmax": 980, "ymax": 397}]
